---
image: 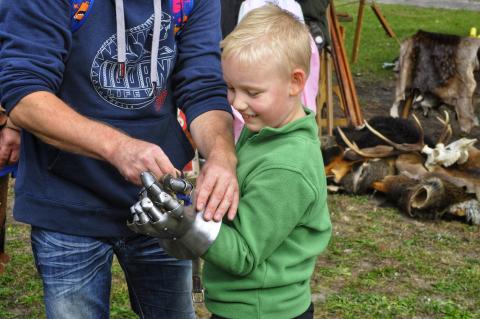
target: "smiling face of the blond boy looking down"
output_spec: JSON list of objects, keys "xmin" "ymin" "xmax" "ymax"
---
[{"xmin": 222, "ymin": 57, "xmax": 305, "ymax": 132}]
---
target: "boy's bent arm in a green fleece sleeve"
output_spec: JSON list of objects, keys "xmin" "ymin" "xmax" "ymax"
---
[{"xmin": 202, "ymin": 169, "xmax": 317, "ymax": 276}]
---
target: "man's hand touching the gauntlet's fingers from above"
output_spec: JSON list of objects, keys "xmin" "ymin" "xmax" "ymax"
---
[{"xmin": 108, "ymin": 136, "xmax": 179, "ymax": 185}]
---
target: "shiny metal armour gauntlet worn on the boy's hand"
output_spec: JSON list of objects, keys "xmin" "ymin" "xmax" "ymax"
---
[{"xmin": 127, "ymin": 172, "xmax": 221, "ymax": 259}]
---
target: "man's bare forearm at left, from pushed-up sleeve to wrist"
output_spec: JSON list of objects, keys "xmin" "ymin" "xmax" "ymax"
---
[{"xmin": 10, "ymin": 92, "xmax": 127, "ymax": 160}]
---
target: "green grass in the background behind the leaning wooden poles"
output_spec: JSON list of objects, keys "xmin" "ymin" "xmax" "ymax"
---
[{"xmin": 335, "ymin": 0, "xmax": 480, "ymax": 79}]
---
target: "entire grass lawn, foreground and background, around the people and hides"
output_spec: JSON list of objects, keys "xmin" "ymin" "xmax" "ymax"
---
[{"xmin": 0, "ymin": 1, "xmax": 480, "ymax": 319}]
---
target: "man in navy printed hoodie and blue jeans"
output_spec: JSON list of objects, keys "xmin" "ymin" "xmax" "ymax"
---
[{"xmin": 0, "ymin": 0, "xmax": 238, "ymax": 319}]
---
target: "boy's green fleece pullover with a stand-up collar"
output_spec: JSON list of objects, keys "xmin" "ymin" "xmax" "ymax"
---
[{"xmin": 202, "ymin": 110, "xmax": 332, "ymax": 319}]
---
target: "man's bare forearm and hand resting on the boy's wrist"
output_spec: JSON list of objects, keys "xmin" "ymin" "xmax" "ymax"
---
[{"xmin": 190, "ymin": 111, "xmax": 239, "ymax": 221}]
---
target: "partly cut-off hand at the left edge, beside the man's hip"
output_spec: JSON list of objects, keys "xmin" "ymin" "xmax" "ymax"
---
[{"xmin": 0, "ymin": 120, "xmax": 20, "ymax": 168}]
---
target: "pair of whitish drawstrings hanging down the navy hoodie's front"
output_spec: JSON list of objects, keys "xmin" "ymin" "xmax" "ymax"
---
[{"xmin": 115, "ymin": 0, "xmax": 162, "ymax": 96}]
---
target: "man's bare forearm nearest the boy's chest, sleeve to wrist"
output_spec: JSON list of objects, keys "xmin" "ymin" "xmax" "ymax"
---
[{"xmin": 190, "ymin": 111, "xmax": 237, "ymax": 166}]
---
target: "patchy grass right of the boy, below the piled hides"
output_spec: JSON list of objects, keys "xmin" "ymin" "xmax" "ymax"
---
[{"xmin": 312, "ymin": 195, "xmax": 480, "ymax": 318}]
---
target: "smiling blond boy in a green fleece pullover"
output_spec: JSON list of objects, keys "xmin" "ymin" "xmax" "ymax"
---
[{"xmin": 202, "ymin": 5, "xmax": 331, "ymax": 319}]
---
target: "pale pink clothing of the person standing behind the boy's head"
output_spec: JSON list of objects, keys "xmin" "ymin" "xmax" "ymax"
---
[{"xmin": 232, "ymin": 0, "xmax": 320, "ymax": 142}]
